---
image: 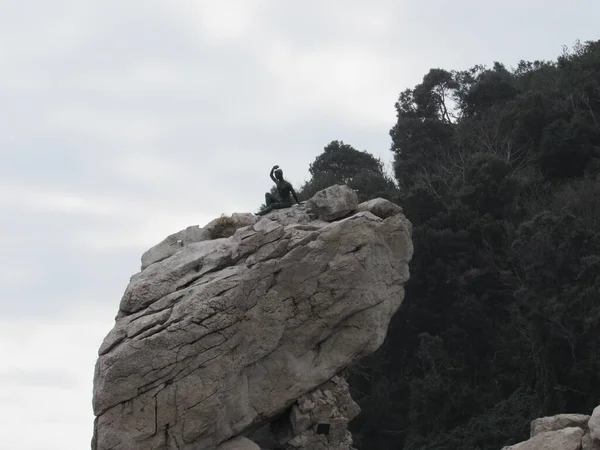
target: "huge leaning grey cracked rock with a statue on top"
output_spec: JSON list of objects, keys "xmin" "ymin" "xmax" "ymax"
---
[{"xmin": 92, "ymin": 186, "xmax": 413, "ymax": 450}]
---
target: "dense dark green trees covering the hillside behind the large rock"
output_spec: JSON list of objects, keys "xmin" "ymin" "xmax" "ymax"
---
[{"xmin": 292, "ymin": 41, "xmax": 600, "ymax": 450}]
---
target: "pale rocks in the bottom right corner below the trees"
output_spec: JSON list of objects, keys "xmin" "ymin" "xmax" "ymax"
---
[{"xmin": 502, "ymin": 406, "xmax": 600, "ymax": 450}]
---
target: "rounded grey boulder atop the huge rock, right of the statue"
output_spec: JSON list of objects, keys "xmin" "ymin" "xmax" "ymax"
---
[{"xmin": 306, "ymin": 184, "xmax": 358, "ymax": 222}]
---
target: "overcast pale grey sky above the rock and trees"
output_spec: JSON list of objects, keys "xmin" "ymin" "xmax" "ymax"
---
[{"xmin": 0, "ymin": 0, "xmax": 600, "ymax": 450}]
